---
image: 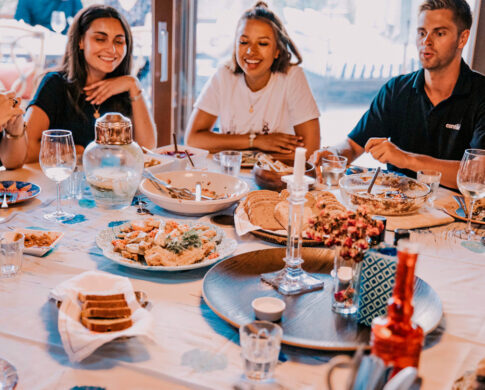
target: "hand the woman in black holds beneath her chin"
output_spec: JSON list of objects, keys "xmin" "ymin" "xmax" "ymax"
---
[{"xmin": 84, "ymin": 76, "xmax": 141, "ymax": 105}]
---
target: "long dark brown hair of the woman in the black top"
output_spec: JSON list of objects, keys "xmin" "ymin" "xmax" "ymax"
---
[{"xmin": 60, "ymin": 5, "xmax": 133, "ymax": 116}]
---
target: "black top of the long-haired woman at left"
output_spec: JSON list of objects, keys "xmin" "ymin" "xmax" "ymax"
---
[{"xmin": 29, "ymin": 72, "xmax": 131, "ymax": 147}]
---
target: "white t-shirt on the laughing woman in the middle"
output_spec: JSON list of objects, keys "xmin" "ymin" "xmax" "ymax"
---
[{"xmin": 194, "ymin": 65, "xmax": 320, "ymax": 134}]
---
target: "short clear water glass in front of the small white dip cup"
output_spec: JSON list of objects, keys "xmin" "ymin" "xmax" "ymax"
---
[{"xmin": 239, "ymin": 321, "xmax": 283, "ymax": 381}]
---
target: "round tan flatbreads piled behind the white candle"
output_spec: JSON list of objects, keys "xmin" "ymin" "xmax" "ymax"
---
[{"xmin": 242, "ymin": 190, "xmax": 346, "ymax": 231}]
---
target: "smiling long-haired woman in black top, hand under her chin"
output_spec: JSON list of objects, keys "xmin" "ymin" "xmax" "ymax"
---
[{"xmin": 26, "ymin": 5, "xmax": 156, "ymax": 162}]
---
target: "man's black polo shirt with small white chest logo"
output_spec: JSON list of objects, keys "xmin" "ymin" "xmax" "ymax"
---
[{"xmin": 349, "ymin": 60, "xmax": 485, "ymax": 177}]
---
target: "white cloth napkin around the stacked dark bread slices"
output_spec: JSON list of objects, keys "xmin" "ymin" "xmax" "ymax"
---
[{"xmin": 49, "ymin": 271, "xmax": 155, "ymax": 363}]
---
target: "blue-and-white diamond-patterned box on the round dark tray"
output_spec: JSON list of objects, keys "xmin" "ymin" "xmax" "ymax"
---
[{"xmin": 357, "ymin": 249, "xmax": 397, "ymax": 326}]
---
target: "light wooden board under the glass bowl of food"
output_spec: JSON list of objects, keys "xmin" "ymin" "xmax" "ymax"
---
[{"xmin": 386, "ymin": 206, "xmax": 455, "ymax": 231}]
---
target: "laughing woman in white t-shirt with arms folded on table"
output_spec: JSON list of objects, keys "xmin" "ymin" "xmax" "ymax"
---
[{"xmin": 187, "ymin": 1, "xmax": 320, "ymax": 154}]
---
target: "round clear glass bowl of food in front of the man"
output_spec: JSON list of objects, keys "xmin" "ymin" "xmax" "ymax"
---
[{"xmin": 340, "ymin": 172, "xmax": 429, "ymax": 215}]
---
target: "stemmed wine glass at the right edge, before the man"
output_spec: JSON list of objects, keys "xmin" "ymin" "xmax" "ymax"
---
[{"xmin": 456, "ymin": 149, "xmax": 485, "ymax": 240}]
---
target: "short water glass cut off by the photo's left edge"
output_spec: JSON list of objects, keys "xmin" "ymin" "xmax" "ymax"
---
[{"xmin": 0, "ymin": 232, "xmax": 25, "ymax": 278}]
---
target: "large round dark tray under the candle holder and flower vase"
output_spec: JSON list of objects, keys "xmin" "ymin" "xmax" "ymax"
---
[{"xmin": 202, "ymin": 248, "xmax": 443, "ymax": 351}]
